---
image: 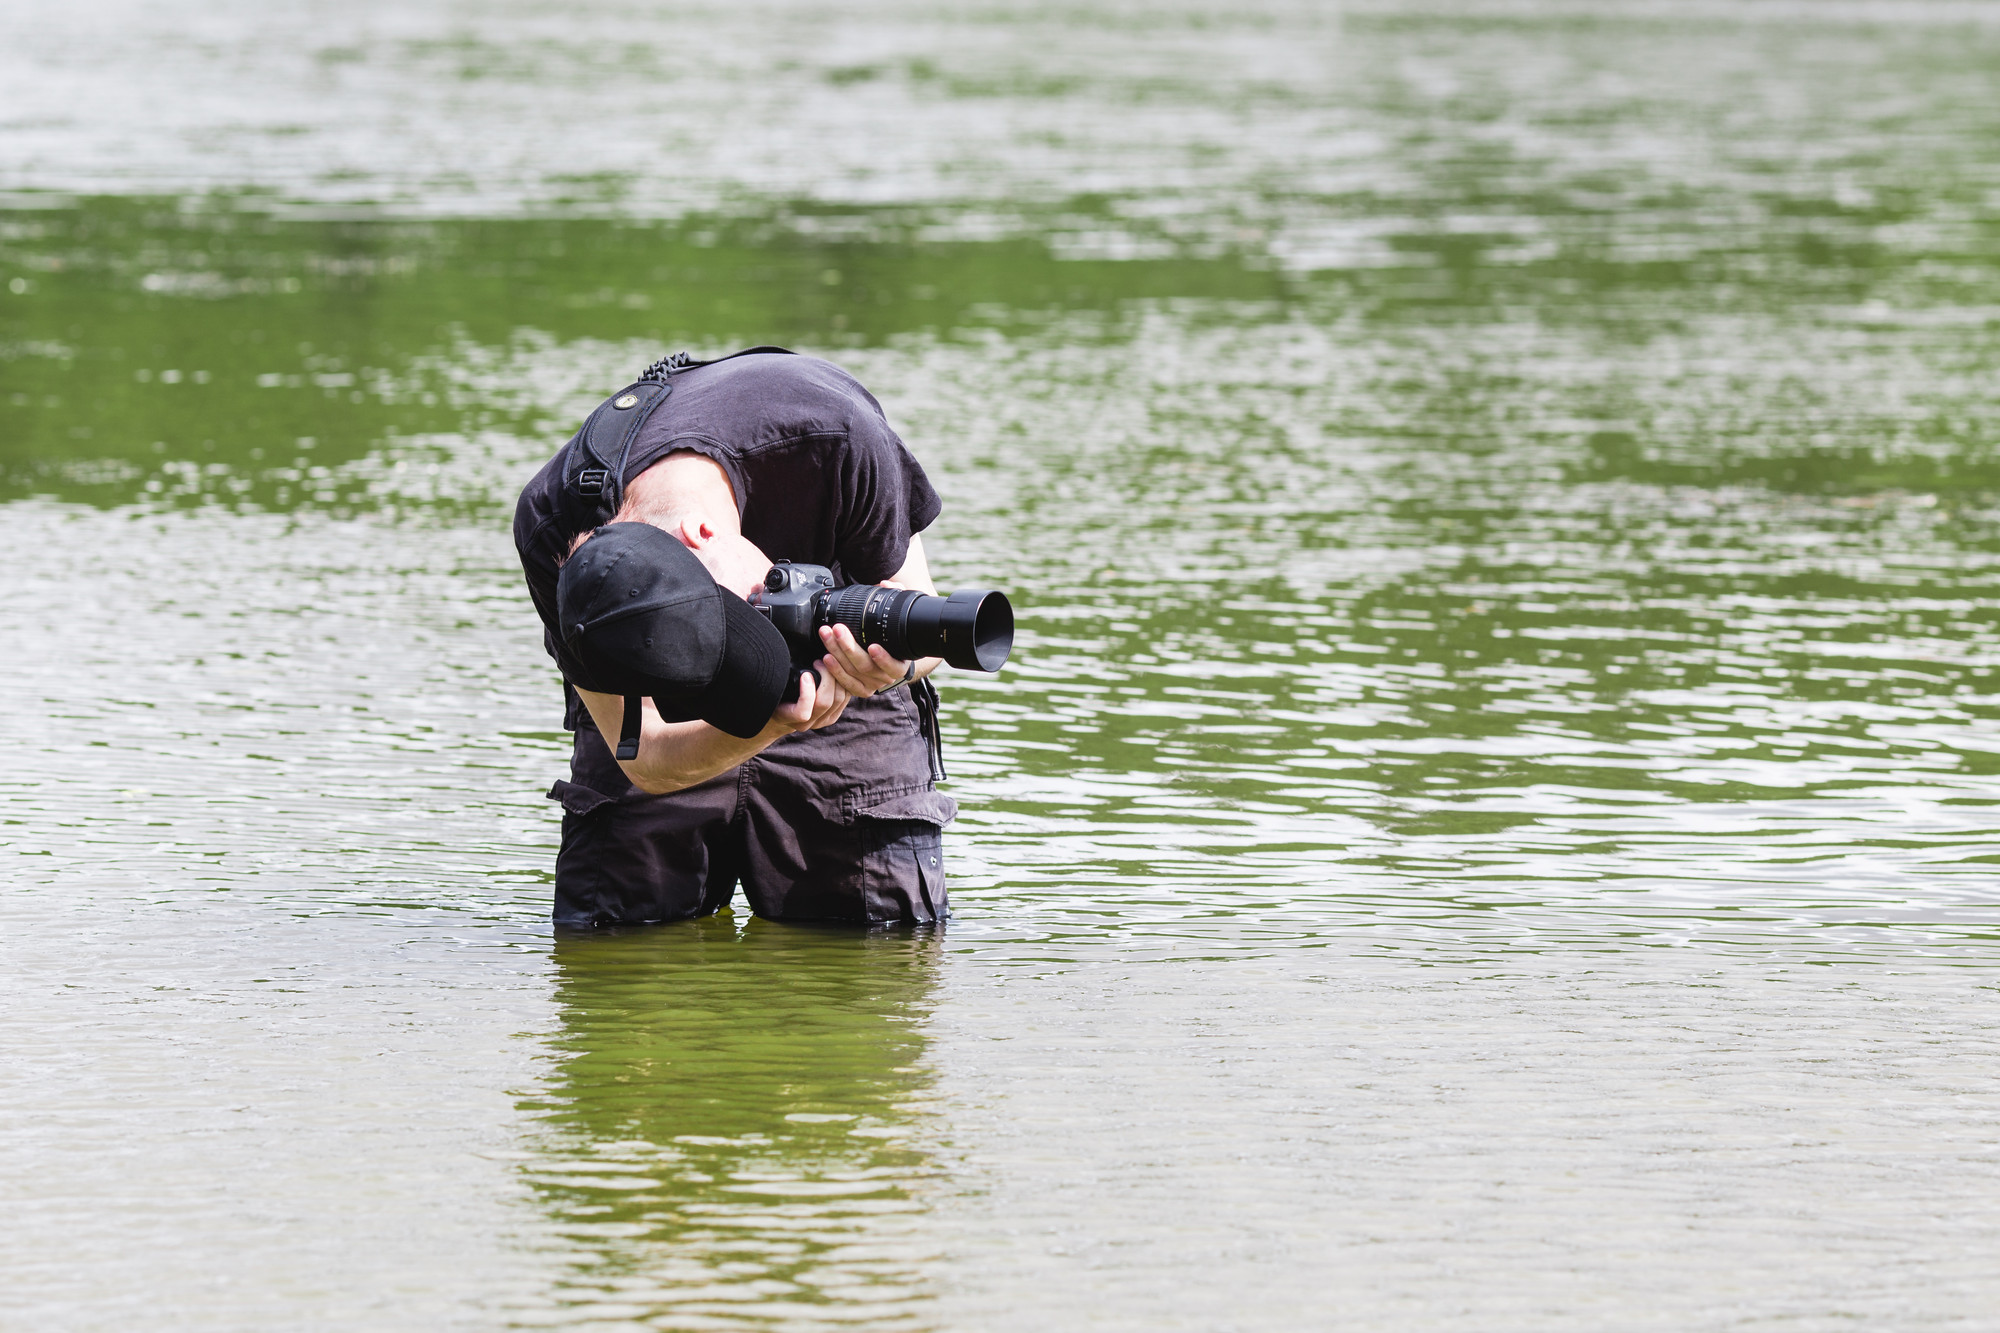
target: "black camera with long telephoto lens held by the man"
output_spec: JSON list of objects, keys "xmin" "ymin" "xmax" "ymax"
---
[{"xmin": 750, "ymin": 560, "xmax": 1014, "ymax": 671}]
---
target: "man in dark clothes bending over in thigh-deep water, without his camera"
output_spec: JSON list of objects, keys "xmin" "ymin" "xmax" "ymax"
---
[{"xmin": 514, "ymin": 348, "xmax": 956, "ymax": 927}]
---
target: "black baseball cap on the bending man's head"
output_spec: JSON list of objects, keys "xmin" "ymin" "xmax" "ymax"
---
[{"xmin": 556, "ymin": 522, "xmax": 792, "ymax": 741}]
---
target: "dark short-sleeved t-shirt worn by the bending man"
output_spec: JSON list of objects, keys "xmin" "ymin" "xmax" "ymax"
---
[{"xmin": 514, "ymin": 352, "xmax": 942, "ymax": 687}]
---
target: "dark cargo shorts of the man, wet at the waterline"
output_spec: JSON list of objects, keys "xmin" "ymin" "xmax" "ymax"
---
[{"xmin": 548, "ymin": 691, "xmax": 958, "ymax": 927}]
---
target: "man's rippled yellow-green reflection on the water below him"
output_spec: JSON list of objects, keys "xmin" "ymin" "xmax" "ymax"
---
[{"xmin": 524, "ymin": 913, "xmax": 942, "ymax": 1329}]
